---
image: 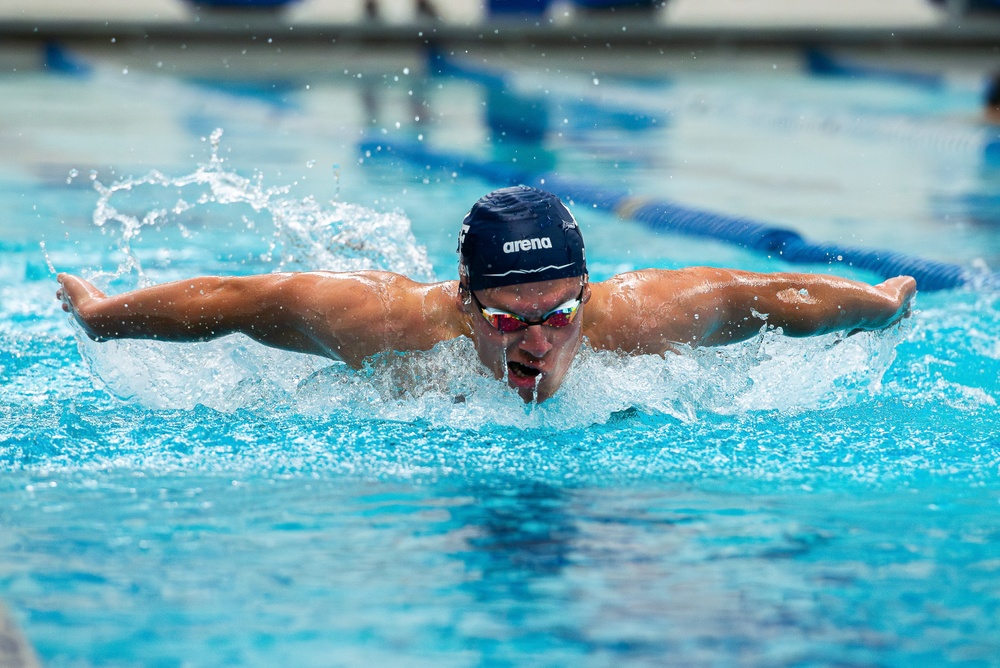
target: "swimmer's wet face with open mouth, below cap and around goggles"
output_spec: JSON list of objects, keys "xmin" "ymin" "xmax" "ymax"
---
[{"xmin": 462, "ymin": 277, "xmax": 590, "ymax": 402}]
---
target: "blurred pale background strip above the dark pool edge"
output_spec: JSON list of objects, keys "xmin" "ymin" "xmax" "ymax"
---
[{"xmin": 0, "ymin": 0, "xmax": 1000, "ymax": 27}]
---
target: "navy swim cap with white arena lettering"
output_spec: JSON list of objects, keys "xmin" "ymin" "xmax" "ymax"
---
[{"xmin": 458, "ymin": 186, "xmax": 587, "ymax": 290}]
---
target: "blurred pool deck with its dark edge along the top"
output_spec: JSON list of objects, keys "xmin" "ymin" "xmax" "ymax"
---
[{"xmin": 0, "ymin": 0, "xmax": 1000, "ymax": 50}]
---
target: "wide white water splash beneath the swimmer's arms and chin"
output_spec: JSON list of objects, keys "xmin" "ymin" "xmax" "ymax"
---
[{"xmin": 82, "ymin": 320, "xmax": 902, "ymax": 429}]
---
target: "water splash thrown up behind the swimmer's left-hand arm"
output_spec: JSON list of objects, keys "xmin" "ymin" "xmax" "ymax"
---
[{"xmin": 82, "ymin": 130, "xmax": 434, "ymax": 288}]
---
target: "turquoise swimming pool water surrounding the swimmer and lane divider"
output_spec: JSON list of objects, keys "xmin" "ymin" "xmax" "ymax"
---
[{"xmin": 0, "ymin": 39, "xmax": 1000, "ymax": 666}]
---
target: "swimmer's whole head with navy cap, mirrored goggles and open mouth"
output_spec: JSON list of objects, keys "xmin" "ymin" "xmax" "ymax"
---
[{"xmin": 457, "ymin": 186, "xmax": 590, "ymax": 401}]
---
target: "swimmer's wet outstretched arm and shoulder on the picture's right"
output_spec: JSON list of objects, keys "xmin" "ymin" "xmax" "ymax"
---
[{"xmin": 595, "ymin": 267, "xmax": 916, "ymax": 353}]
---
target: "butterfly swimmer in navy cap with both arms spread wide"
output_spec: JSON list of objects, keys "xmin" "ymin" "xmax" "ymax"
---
[{"xmin": 57, "ymin": 186, "xmax": 916, "ymax": 402}]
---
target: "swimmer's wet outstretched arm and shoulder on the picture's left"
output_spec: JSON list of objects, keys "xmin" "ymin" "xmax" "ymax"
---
[{"xmin": 57, "ymin": 272, "xmax": 460, "ymax": 366}]
